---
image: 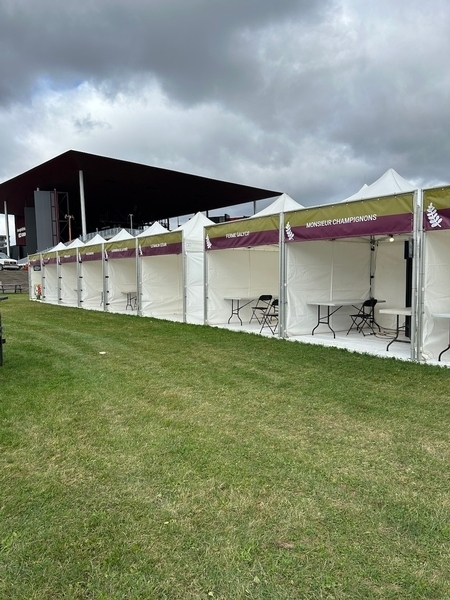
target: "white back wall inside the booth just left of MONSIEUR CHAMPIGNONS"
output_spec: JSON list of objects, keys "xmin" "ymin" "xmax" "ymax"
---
[{"xmin": 207, "ymin": 246, "xmax": 279, "ymax": 324}]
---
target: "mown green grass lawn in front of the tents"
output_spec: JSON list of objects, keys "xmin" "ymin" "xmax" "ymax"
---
[{"xmin": 0, "ymin": 295, "xmax": 450, "ymax": 600}]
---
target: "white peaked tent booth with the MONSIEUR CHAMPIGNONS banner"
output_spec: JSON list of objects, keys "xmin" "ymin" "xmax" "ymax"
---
[{"xmin": 284, "ymin": 169, "xmax": 418, "ymax": 352}]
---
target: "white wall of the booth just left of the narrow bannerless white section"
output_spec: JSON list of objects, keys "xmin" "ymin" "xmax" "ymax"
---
[{"xmin": 139, "ymin": 254, "xmax": 183, "ymax": 321}]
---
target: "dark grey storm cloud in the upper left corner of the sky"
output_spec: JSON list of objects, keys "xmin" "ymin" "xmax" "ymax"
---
[{"xmin": 0, "ymin": 0, "xmax": 325, "ymax": 102}]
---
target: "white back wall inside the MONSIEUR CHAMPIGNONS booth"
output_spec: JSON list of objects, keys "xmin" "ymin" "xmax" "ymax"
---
[{"xmin": 286, "ymin": 240, "xmax": 370, "ymax": 337}]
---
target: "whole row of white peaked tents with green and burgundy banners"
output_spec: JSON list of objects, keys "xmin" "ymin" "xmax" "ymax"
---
[{"xmin": 29, "ymin": 169, "xmax": 450, "ymax": 362}]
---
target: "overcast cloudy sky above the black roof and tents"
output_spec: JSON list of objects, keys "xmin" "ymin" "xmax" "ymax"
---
[{"xmin": 0, "ymin": 0, "xmax": 450, "ymax": 221}]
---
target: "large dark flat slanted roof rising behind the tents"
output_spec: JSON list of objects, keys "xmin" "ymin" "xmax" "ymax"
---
[{"xmin": 0, "ymin": 150, "xmax": 281, "ymax": 236}]
